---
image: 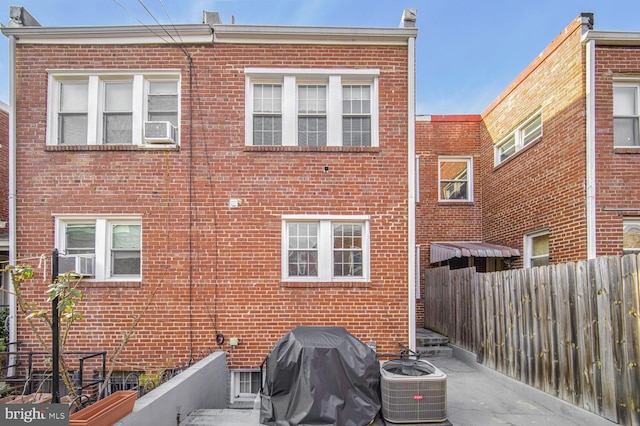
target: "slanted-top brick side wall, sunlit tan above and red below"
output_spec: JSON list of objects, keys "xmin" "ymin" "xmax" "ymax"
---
[{"xmin": 480, "ymin": 19, "xmax": 586, "ymax": 266}]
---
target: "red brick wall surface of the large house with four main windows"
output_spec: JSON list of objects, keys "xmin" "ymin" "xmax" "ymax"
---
[{"xmin": 16, "ymin": 44, "xmax": 409, "ymax": 369}]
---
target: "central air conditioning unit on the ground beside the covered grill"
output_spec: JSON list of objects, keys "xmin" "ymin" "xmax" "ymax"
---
[{"xmin": 380, "ymin": 359, "xmax": 447, "ymax": 423}]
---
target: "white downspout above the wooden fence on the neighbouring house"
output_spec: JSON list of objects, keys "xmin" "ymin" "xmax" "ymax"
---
[{"xmin": 585, "ymin": 40, "xmax": 596, "ymax": 259}]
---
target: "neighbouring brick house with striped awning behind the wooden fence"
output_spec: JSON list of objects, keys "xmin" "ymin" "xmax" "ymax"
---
[{"xmin": 416, "ymin": 14, "xmax": 640, "ymax": 321}]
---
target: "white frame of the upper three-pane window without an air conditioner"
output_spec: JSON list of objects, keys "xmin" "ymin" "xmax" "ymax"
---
[{"xmin": 244, "ymin": 68, "xmax": 380, "ymax": 147}]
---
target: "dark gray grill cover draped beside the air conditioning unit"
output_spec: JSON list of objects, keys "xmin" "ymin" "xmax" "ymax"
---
[{"xmin": 260, "ymin": 326, "xmax": 381, "ymax": 426}]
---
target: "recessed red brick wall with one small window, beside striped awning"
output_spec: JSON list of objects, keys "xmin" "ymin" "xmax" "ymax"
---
[{"xmin": 416, "ymin": 115, "xmax": 482, "ymax": 326}]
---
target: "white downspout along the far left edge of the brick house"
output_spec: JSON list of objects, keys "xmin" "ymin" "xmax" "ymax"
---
[{"xmin": 7, "ymin": 35, "xmax": 18, "ymax": 356}]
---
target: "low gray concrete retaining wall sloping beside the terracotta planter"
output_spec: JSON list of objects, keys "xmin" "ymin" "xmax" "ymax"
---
[{"xmin": 115, "ymin": 351, "xmax": 227, "ymax": 426}]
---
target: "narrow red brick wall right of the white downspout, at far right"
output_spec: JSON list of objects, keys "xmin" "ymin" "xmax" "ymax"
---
[{"xmin": 595, "ymin": 44, "xmax": 640, "ymax": 256}]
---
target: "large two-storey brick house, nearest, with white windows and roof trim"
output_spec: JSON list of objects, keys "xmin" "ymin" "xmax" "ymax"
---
[{"xmin": 3, "ymin": 12, "xmax": 417, "ymax": 402}]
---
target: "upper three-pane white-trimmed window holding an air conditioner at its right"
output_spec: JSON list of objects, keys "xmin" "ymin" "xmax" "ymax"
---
[{"xmin": 47, "ymin": 71, "xmax": 180, "ymax": 146}]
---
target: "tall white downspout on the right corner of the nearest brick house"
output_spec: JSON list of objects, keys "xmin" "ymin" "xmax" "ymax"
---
[{"xmin": 404, "ymin": 9, "xmax": 417, "ymax": 351}]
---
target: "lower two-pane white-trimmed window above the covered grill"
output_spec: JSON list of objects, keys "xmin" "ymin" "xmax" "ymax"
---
[{"xmin": 282, "ymin": 215, "xmax": 369, "ymax": 281}]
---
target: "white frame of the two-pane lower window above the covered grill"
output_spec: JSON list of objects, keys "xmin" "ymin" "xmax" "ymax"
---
[{"xmin": 281, "ymin": 215, "xmax": 370, "ymax": 282}]
